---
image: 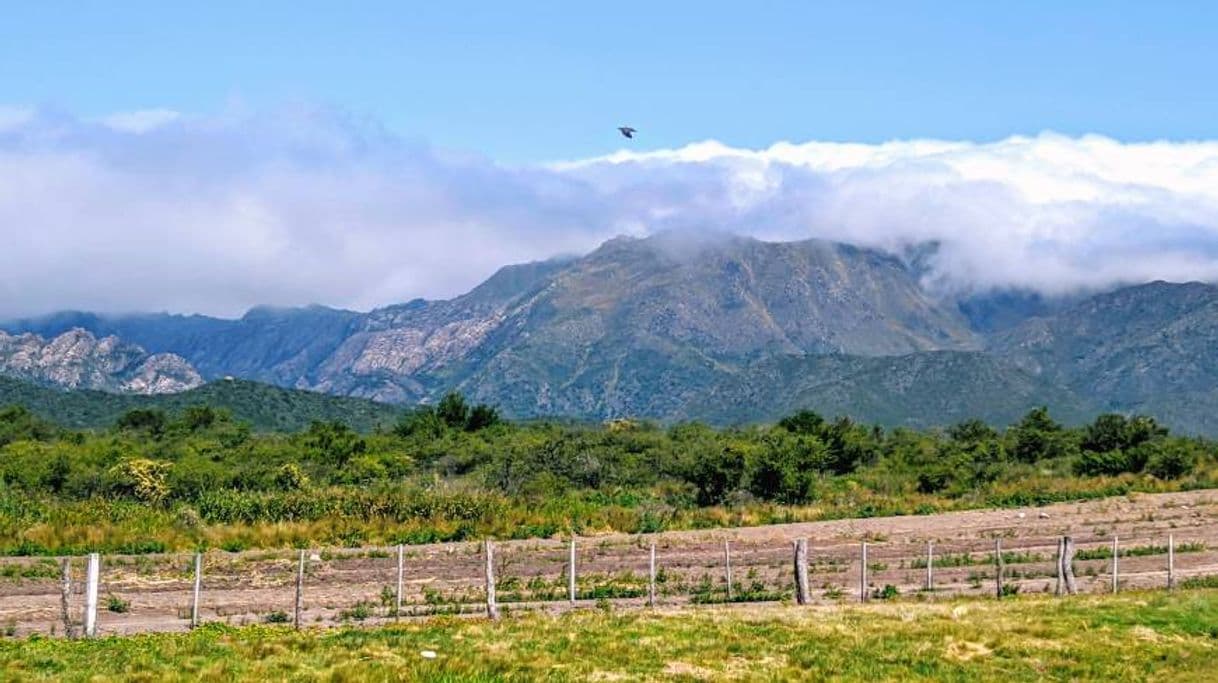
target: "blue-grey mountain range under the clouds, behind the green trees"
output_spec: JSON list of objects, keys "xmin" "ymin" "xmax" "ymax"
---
[{"xmin": 0, "ymin": 233, "xmax": 1218, "ymax": 433}]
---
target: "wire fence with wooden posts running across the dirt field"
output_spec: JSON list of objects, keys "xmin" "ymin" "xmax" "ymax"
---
[{"xmin": 0, "ymin": 530, "xmax": 1218, "ymax": 637}]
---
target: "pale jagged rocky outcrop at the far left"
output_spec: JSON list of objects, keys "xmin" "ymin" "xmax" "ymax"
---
[{"xmin": 0, "ymin": 327, "xmax": 203, "ymax": 394}]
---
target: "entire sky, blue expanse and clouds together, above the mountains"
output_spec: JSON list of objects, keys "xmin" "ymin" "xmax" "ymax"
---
[{"xmin": 0, "ymin": 1, "xmax": 1218, "ymax": 317}]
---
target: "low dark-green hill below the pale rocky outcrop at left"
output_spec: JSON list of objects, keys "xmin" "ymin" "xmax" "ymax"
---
[{"xmin": 0, "ymin": 376, "xmax": 401, "ymax": 432}]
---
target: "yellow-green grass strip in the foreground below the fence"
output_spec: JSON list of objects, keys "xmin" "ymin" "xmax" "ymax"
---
[{"xmin": 0, "ymin": 589, "xmax": 1218, "ymax": 681}]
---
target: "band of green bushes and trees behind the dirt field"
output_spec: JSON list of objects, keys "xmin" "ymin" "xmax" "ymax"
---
[{"xmin": 0, "ymin": 394, "xmax": 1218, "ymax": 554}]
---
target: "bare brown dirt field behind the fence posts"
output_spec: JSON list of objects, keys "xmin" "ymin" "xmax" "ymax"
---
[{"xmin": 0, "ymin": 491, "xmax": 1218, "ymax": 634}]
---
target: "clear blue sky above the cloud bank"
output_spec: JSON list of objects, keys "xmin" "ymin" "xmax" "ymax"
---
[{"xmin": 0, "ymin": 1, "xmax": 1218, "ymax": 162}]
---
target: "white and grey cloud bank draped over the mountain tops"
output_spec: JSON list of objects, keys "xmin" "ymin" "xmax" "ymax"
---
[{"xmin": 0, "ymin": 106, "xmax": 1218, "ymax": 318}]
